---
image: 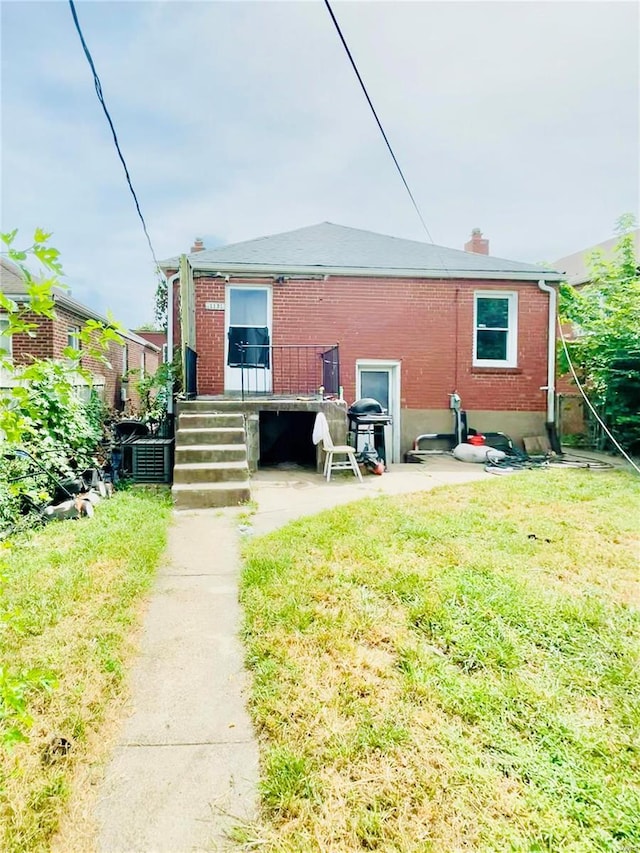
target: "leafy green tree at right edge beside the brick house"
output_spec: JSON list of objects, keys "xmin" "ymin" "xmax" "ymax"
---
[{"xmin": 559, "ymin": 214, "xmax": 640, "ymax": 453}]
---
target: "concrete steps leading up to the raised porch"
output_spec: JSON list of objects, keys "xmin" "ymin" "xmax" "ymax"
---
[{"xmin": 171, "ymin": 402, "xmax": 251, "ymax": 509}]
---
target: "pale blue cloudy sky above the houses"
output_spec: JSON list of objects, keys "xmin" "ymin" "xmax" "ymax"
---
[{"xmin": 0, "ymin": 0, "xmax": 640, "ymax": 327}]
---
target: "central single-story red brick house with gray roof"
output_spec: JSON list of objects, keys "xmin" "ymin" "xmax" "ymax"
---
[{"xmin": 161, "ymin": 223, "xmax": 561, "ymax": 461}]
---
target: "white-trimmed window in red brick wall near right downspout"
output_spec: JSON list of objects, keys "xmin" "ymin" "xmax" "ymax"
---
[{"xmin": 473, "ymin": 290, "xmax": 518, "ymax": 367}]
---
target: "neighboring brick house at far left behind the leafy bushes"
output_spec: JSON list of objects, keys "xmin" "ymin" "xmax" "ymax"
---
[{"xmin": 0, "ymin": 258, "xmax": 161, "ymax": 412}]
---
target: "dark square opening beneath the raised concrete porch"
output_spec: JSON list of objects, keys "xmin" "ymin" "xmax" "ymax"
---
[{"xmin": 260, "ymin": 412, "xmax": 316, "ymax": 469}]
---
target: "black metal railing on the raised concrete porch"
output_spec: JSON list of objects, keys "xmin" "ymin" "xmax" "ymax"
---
[{"xmin": 237, "ymin": 344, "xmax": 340, "ymax": 400}]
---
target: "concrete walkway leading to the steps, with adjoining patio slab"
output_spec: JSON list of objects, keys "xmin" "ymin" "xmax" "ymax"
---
[{"xmin": 95, "ymin": 457, "xmax": 493, "ymax": 853}]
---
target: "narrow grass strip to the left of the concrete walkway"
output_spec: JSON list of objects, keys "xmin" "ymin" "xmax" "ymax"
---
[{"xmin": 0, "ymin": 490, "xmax": 170, "ymax": 853}]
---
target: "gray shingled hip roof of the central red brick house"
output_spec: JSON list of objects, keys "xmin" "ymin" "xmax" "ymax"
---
[{"xmin": 161, "ymin": 222, "xmax": 560, "ymax": 280}]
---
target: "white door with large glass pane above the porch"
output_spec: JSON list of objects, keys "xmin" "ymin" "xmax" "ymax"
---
[{"xmin": 224, "ymin": 285, "xmax": 272, "ymax": 394}]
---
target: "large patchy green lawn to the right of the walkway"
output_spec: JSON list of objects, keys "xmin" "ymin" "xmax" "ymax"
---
[{"xmin": 237, "ymin": 470, "xmax": 640, "ymax": 853}]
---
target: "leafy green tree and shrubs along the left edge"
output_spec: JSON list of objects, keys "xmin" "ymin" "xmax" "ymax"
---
[{"xmin": 0, "ymin": 228, "xmax": 131, "ymax": 747}]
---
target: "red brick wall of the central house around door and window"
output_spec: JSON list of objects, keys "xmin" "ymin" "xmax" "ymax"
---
[{"xmin": 189, "ymin": 277, "xmax": 548, "ymax": 412}]
